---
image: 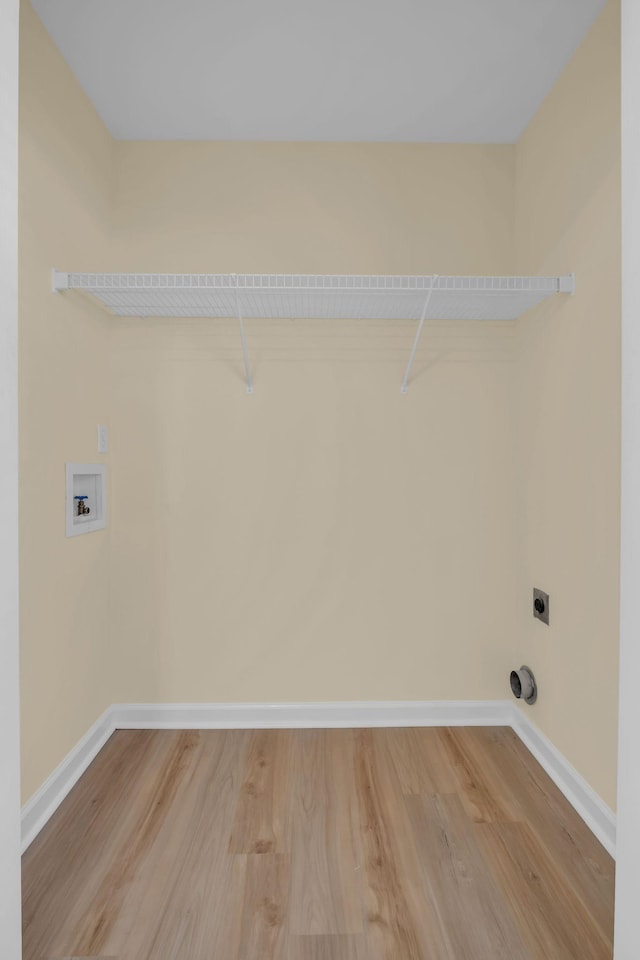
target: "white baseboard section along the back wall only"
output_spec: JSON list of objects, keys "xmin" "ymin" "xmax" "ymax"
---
[{"xmin": 113, "ymin": 700, "xmax": 511, "ymax": 730}]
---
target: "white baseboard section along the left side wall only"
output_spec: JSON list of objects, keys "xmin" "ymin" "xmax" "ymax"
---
[{"xmin": 21, "ymin": 707, "xmax": 115, "ymax": 853}]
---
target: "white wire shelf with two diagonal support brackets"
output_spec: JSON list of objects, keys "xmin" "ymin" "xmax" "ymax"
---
[{"xmin": 52, "ymin": 270, "xmax": 575, "ymax": 393}]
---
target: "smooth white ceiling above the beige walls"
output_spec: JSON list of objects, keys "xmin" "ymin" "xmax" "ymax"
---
[{"xmin": 32, "ymin": 0, "xmax": 604, "ymax": 143}]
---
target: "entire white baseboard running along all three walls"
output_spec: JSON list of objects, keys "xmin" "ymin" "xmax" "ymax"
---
[{"xmin": 22, "ymin": 700, "xmax": 616, "ymax": 857}]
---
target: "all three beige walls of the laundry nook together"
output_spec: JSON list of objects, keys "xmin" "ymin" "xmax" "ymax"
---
[{"xmin": 20, "ymin": 2, "xmax": 619, "ymax": 804}]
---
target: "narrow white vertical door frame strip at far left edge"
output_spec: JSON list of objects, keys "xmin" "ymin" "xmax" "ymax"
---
[{"xmin": 0, "ymin": 0, "xmax": 22, "ymax": 948}]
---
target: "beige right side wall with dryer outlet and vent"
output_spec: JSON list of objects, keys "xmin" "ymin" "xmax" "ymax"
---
[{"xmin": 516, "ymin": 0, "xmax": 621, "ymax": 807}]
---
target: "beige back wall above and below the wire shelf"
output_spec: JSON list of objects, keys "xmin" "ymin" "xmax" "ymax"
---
[{"xmin": 111, "ymin": 143, "xmax": 515, "ymax": 701}]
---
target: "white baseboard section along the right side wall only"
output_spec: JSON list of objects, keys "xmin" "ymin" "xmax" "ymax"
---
[{"xmin": 509, "ymin": 703, "xmax": 616, "ymax": 859}]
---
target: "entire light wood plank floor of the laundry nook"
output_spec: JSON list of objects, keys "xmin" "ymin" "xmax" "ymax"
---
[{"xmin": 23, "ymin": 728, "xmax": 614, "ymax": 960}]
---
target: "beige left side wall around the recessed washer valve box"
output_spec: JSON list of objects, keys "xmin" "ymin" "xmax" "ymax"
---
[{"xmin": 19, "ymin": 3, "xmax": 114, "ymax": 800}]
